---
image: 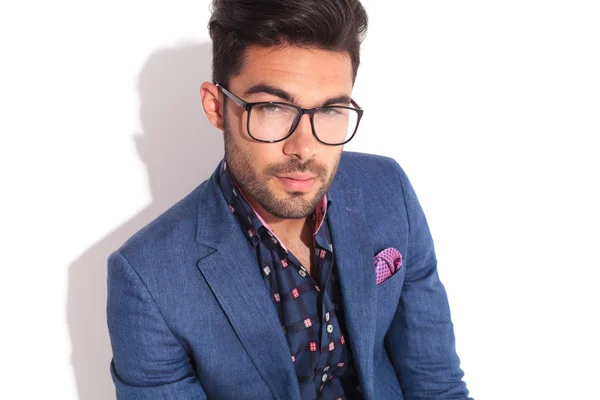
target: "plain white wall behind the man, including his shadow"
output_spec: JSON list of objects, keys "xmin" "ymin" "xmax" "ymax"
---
[{"xmin": 0, "ymin": 0, "xmax": 600, "ymax": 400}]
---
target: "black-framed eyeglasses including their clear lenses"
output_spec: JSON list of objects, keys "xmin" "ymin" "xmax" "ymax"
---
[{"xmin": 217, "ymin": 84, "xmax": 363, "ymax": 146}]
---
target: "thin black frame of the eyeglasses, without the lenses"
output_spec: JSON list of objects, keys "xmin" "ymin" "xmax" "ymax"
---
[{"xmin": 216, "ymin": 83, "xmax": 364, "ymax": 146}]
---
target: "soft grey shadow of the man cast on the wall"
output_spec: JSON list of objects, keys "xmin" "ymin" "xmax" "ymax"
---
[{"xmin": 67, "ymin": 43, "xmax": 223, "ymax": 400}]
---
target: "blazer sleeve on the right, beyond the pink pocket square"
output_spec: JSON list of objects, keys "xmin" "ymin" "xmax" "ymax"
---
[{"xmin": 385, "ymin": 161, "xmax": 472, "ymax": 400}]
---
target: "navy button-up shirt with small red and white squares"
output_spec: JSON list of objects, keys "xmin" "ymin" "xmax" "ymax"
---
[{"xmin": 219, "ymin": 161, "xmax": 362, "ymax": 400}]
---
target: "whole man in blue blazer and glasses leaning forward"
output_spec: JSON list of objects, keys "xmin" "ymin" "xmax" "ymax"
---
[{"xmin": 108, "ymin": 0, "xmax": 468, "ymax": 399}]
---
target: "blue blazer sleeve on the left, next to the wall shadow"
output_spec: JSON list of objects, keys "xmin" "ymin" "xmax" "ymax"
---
[{"xmin": 107, "ymin": 251, "xmax": 206, "ymax": 400}]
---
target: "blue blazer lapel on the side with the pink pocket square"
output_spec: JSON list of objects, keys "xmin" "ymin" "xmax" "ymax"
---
[{"xmin": 327, "ymin": 184, "xmax": 376, "ymax": 399}]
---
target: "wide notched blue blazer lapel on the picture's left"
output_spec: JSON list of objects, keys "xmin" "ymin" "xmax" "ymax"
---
[{"xmin": 196, "ymin": 169, "xmax": 300, "ymax": 400}]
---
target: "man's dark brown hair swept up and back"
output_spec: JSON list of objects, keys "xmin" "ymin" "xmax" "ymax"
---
[{"xmin": 208, "ymin": 0, "xmax": 368, "ymax": 85}]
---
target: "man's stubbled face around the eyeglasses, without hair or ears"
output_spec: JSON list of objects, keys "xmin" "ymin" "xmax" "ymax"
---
[{"xmin": 223, "ymin": 47, "xmax": 353, "ymax": 219}]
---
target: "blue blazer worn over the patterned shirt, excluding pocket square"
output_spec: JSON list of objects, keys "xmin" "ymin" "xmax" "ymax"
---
[{"xmin": 107, "ymin": 152, "xmax": 468, "ymax": 400}]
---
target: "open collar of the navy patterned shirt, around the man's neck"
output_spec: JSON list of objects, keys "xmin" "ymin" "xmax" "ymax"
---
[{"xmin": 219, "ymin": 160, "xmax": 331, "ymax": 251}]
